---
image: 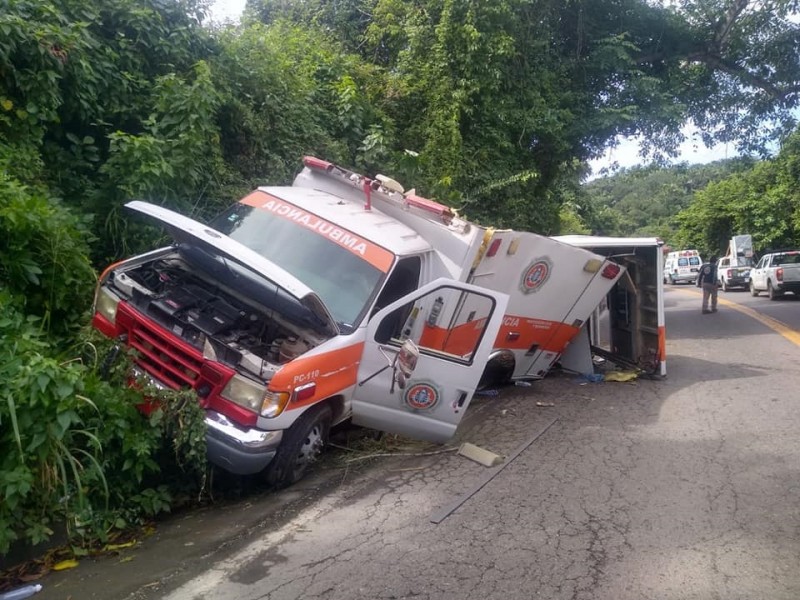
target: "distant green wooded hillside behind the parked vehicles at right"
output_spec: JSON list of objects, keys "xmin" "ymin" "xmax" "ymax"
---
[{"xmin": 577, "ymin": 132, "xmax": 800, "ymax": 256}]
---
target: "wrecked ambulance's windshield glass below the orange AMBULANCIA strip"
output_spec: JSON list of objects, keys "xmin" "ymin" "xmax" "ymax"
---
[{"xmin": 211, "ymin": 204, "xmax": 383, "ymax": 332}]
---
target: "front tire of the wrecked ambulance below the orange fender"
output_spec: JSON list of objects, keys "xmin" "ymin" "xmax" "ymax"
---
[{"xmin": 266, "ymin": 405, "xmax": 332, "ymax": 489}]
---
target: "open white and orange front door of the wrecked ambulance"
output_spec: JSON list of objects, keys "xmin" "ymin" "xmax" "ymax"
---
[{"xmin": 352, "ymin": 279, "xmax": 508, "ymax": 443}]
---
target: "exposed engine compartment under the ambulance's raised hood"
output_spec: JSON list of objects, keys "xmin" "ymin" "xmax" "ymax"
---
[{"xmin": 105, "ymin": 252, "xmax": 327, "ymax": 381}]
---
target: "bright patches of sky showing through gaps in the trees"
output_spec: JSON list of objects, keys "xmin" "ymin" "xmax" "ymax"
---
[{"xmin": 211, "ymin": 0, "xmax": 737, "ymax": 179}]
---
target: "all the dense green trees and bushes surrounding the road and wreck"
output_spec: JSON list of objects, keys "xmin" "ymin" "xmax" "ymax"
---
[{"xmin": 0, "ymin": 0, "xmax": 800, "ymax": 553}]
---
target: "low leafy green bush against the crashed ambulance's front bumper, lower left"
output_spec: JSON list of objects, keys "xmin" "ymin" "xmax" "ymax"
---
[{"xmin": 0, "ymin": 308, "xmax": 206, "ymax": 553}]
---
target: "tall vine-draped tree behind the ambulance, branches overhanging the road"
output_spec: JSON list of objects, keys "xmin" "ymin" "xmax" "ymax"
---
[{"xmin": 250, "ymin": 0, "xmax": 800, "ymax": 232}]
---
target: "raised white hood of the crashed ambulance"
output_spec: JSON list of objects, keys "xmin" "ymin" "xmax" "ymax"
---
[{"xmin": 125, "ymin": 200, "xmax": 339, "ymax": 335}]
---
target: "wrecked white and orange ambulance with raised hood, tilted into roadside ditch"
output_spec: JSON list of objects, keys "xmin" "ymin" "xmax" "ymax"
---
[{"xmin": 93, "ymin": 157, "xmax": 625, "ymax": 487}]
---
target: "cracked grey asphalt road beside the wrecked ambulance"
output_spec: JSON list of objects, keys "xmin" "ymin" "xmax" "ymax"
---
[{"xmin": 36, "ymin": 289, "xmax": 800, "ymax": 600}]
